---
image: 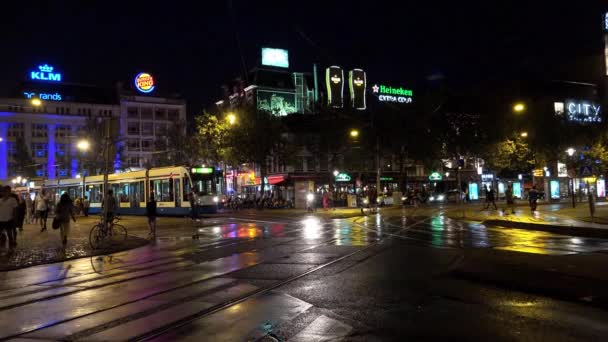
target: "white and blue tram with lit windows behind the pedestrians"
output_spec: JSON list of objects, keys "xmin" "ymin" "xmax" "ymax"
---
[{"xmin": 33, "ymin": 166, "xmax": 221, "ymax": 216}]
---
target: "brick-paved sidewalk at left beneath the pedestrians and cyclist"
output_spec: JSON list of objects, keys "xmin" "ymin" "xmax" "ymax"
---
[{"xmin": 0, "ymin": 217, "xmax": 148, "ymax": 271}]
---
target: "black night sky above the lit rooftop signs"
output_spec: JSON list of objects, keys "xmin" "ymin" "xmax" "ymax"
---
[{"xmin": 0, "ymin": 0, "xmax": 608, "ymax": 114}]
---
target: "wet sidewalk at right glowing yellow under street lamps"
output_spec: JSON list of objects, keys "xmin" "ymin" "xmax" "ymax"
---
[{"xmin": 446, "ymin": 202, "xmax": 608, "ymax": 238}]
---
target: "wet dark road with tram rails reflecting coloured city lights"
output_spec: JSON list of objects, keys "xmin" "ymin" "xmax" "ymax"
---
[{"xmin": 0, "ymin": 212, "xmax": 608, "ymax": 341}]
